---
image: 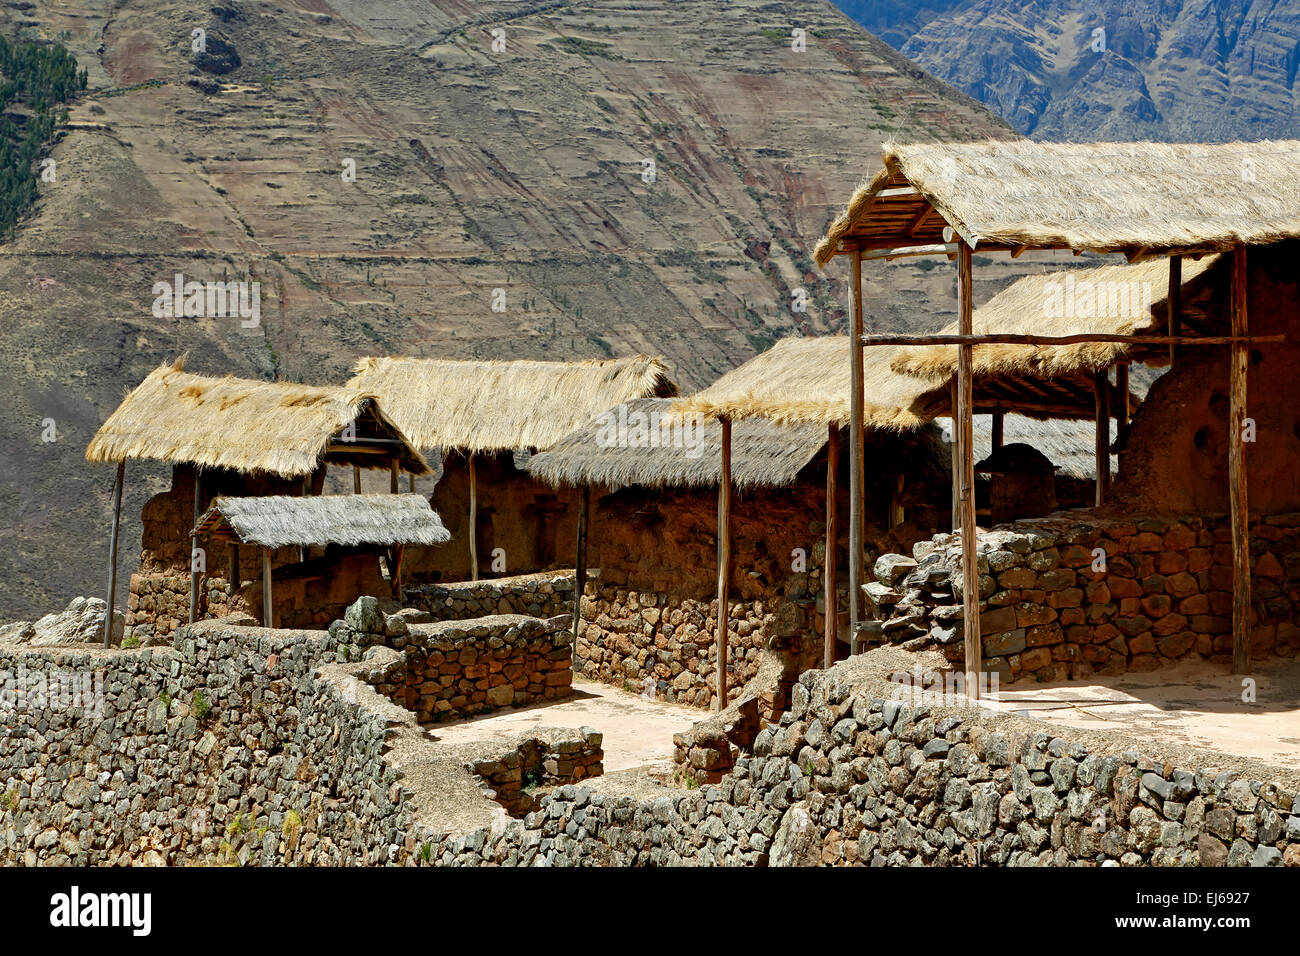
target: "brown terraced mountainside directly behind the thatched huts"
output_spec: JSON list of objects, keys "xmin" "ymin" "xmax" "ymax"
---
[{"xmin": 0, "ymin": 0, "xmax": 1013, "ymax": 619}]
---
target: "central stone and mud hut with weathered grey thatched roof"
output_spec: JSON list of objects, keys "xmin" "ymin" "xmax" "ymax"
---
[{"xmin": 529, "ymin": 338, "xmax": 948, "ymax": 713}]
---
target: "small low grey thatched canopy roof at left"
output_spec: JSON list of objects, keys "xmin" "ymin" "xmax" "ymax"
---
[{"xmin": 194, "ymin": 494, "xmax": 451, "ymax": 548}]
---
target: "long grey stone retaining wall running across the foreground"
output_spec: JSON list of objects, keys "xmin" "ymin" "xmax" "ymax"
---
[{"xmin": 0, "ymin": 622, "xmax": 1300, "ymax": 866}]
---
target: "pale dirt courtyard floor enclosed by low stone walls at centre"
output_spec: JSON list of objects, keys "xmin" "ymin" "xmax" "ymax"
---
[{"xmin": 428, "ymin": 680, "xmax": 709, "ymax": 774}]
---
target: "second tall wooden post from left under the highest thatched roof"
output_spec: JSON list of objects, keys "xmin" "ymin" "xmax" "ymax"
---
[{"xmin": 957, "ymin": 242, "xmax": 984, "ymax": 700}]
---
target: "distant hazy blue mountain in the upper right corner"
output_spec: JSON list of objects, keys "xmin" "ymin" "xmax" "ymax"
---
[{"xmin": 840, "ymin": 0, "xmax": 1300, "ymax": 142}]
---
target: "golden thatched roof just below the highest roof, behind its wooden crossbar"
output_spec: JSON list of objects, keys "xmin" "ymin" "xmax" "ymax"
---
[{"xmin": 892, "ymin": 256, "xmax": 1226, "ymax": 384}]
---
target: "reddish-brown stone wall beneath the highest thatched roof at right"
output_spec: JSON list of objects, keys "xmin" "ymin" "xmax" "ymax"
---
[{"xmin": 867, "ymin": 514, "xmax": 1300, "ymax": 680}]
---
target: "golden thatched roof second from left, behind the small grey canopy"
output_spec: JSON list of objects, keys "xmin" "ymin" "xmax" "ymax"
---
[{"xmin": 348, "ymin": 355, "xmax": 677, "ymax": 454}]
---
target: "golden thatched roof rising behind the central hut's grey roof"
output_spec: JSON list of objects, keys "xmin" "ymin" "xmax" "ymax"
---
[{"xmin": 676, "ymin": 336, "xmax": 935, "ymax": 429}]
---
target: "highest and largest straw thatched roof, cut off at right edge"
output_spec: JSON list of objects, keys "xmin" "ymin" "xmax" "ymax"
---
[{"xmin": 815, "ymin": 139, "xmax": 1300, "ymax": 267}]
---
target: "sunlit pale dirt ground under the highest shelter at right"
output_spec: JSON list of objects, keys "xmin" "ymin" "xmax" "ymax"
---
[{"xmin": 985, "ymin": 659, "xmax": 1300, "ymax": 767}]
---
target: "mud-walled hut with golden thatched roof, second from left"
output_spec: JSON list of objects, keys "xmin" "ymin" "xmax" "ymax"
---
[{"xmin": 348, "ymin": 355, "xmax": 677, "ymax": 581}]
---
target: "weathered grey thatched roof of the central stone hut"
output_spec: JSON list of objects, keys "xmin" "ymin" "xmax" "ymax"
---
[{"xmin": 528, "ymin": 398, "xmax": 827, "ymax": 488}]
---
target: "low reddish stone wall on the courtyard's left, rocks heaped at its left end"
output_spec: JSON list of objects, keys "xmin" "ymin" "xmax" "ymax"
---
[{"xmin": 330, "ymin": 597, "xmax": 573, "ymax": 723}]
